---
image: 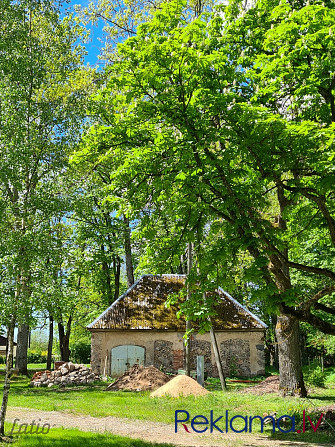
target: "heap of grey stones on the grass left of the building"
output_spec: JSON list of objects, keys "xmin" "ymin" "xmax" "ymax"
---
[{"xmin": 30, "ymin": 362, "xmax": 100, "ymax": 387}]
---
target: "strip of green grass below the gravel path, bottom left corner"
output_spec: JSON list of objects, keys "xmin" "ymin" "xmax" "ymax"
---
[{"xmin": 0, "ymin": 424, "xmax": 173, "ymax": 447}]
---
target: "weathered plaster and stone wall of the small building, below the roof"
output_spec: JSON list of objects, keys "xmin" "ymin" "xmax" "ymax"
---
[{"xmin": 91, "ymin": 330, "xmax": 264, "ymax": 376}]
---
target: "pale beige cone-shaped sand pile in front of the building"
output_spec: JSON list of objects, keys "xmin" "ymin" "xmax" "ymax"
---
[{"xmin": 150, "ymin": 376, "xmax": 209, "ymax": 397}]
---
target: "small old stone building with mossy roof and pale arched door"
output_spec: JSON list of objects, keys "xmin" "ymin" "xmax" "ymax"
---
[{"xmin": 87, "ymin": 275, "xmax": 267, "ymax": 377}]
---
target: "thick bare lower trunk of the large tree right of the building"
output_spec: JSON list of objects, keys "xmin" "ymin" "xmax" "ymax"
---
[{"xmin": 276, "ymin": 315, "xmax": 307, "ymax": 397}]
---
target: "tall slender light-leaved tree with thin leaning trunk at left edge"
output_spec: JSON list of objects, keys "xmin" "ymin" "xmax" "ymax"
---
[{"xmin": 0, "ymin": 0, "xmax": 92, "ymax": 434}]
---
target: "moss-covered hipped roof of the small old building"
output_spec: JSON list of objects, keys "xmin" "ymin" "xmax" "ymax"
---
[{"xmin": 87, "ymin": 275, "xmax": 267, "ymax": 331}]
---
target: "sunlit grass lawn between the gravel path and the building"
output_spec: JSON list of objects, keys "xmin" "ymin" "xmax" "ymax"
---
[{"xmin": 1, "ymin": 377, "xmax": 335, "ymax": 446}]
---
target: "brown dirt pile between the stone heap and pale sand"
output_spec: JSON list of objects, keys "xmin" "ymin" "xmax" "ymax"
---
[{"xmin": 106, "ymin": 365, "xmax": 170, "ymax": 391}]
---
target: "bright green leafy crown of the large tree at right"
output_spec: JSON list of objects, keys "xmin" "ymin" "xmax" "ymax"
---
[{"xmin": 72, "ymin": 1, "xmax": 335, "ymax": 344}]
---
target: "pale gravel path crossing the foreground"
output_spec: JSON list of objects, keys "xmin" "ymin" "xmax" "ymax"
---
[{"xmin": 6, "ymin": 407, "xmax": 328, "ymax": 447}]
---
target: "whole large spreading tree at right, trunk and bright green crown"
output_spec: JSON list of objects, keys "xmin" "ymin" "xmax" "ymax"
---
[{"xmin": 75, "ymin": 2, "xmax": 335, "ymax": 396}]
